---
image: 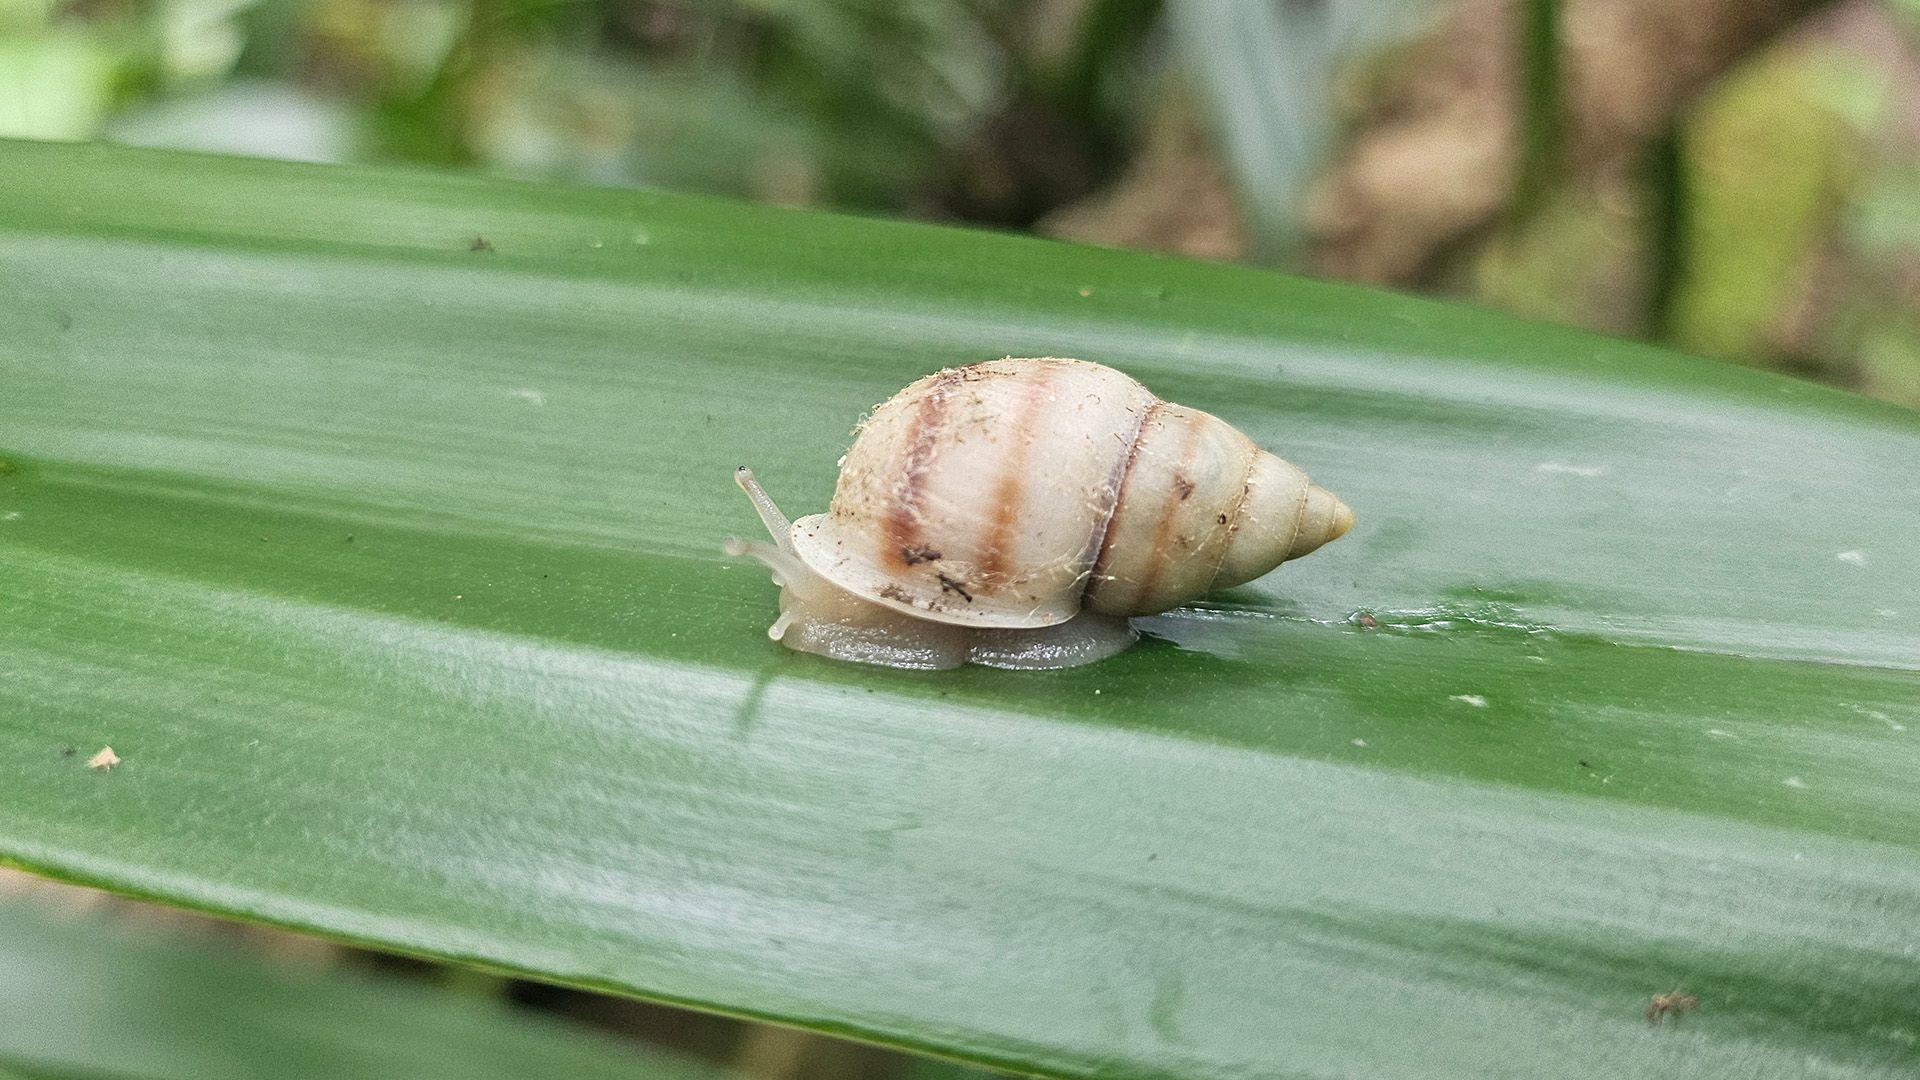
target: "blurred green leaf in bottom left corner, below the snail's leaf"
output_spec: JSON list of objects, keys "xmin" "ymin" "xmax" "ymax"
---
[{"xmin": 0, "ymin": 887, "xmax": 732, "ymax": 1080}]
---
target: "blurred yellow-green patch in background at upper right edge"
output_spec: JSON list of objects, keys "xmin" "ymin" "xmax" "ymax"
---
[{"xmin": 1670, "ymin": 16, "xmax": 1920, "ymax": 405}]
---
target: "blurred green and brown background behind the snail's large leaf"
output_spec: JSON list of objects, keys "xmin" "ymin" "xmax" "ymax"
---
[{"xmin": 0, "ymin": 0, "xmax": 1920, "ymax": 1080}]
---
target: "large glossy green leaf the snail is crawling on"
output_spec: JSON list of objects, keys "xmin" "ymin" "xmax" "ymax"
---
[{"xmin": 0, "ymin": 144, "xmax": 1920, "ymax": 1078}]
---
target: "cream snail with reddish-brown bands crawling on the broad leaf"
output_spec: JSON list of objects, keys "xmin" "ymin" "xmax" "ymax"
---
[{"xmin": 726, "ymin": 357, "xmax": 1354, "ymax": 669}]
